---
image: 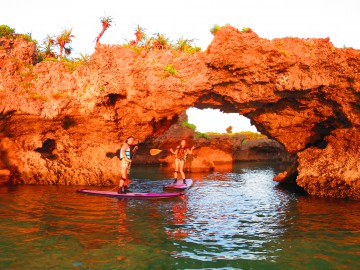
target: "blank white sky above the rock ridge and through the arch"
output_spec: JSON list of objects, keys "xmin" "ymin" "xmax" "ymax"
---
[{"xmin": 0, "ymin": 0, "xmax": 360, "ymax": 132}]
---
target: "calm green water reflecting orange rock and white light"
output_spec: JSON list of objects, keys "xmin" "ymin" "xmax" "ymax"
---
[{"xmin": 0, "ymin": 163, "xmax": 360, "ymax": 269}]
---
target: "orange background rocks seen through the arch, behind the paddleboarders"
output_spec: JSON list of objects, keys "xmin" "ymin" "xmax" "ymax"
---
[{"xmin": 135, "ymin": 113, "xmax": 294, "ymax": 172}]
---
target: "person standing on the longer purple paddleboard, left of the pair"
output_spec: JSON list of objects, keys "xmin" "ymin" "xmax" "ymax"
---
[{"xmin": 118, "ymin": 136, "xmax": 138, "ymax": 193}]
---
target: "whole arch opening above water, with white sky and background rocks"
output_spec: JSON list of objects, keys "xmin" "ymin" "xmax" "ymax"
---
[{"xmin": 137, "ymin": 106, "xmax": 290, "ymax": 176}]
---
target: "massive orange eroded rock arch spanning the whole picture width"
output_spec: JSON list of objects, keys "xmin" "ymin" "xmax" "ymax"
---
[{"xmin": 0, "ymin": 26, "xmax": 360, "ymax": 199}]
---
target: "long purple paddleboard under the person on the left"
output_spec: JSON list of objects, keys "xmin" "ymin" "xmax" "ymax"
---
[{"xmin": 76, "ymin": 189, "xmax": 184, "ymax": 199}]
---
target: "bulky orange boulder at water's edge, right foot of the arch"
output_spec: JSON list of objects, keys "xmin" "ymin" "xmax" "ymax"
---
[{"xmin": 297, "ymin": 128, "xmax": 360, "ymax": 200}]
